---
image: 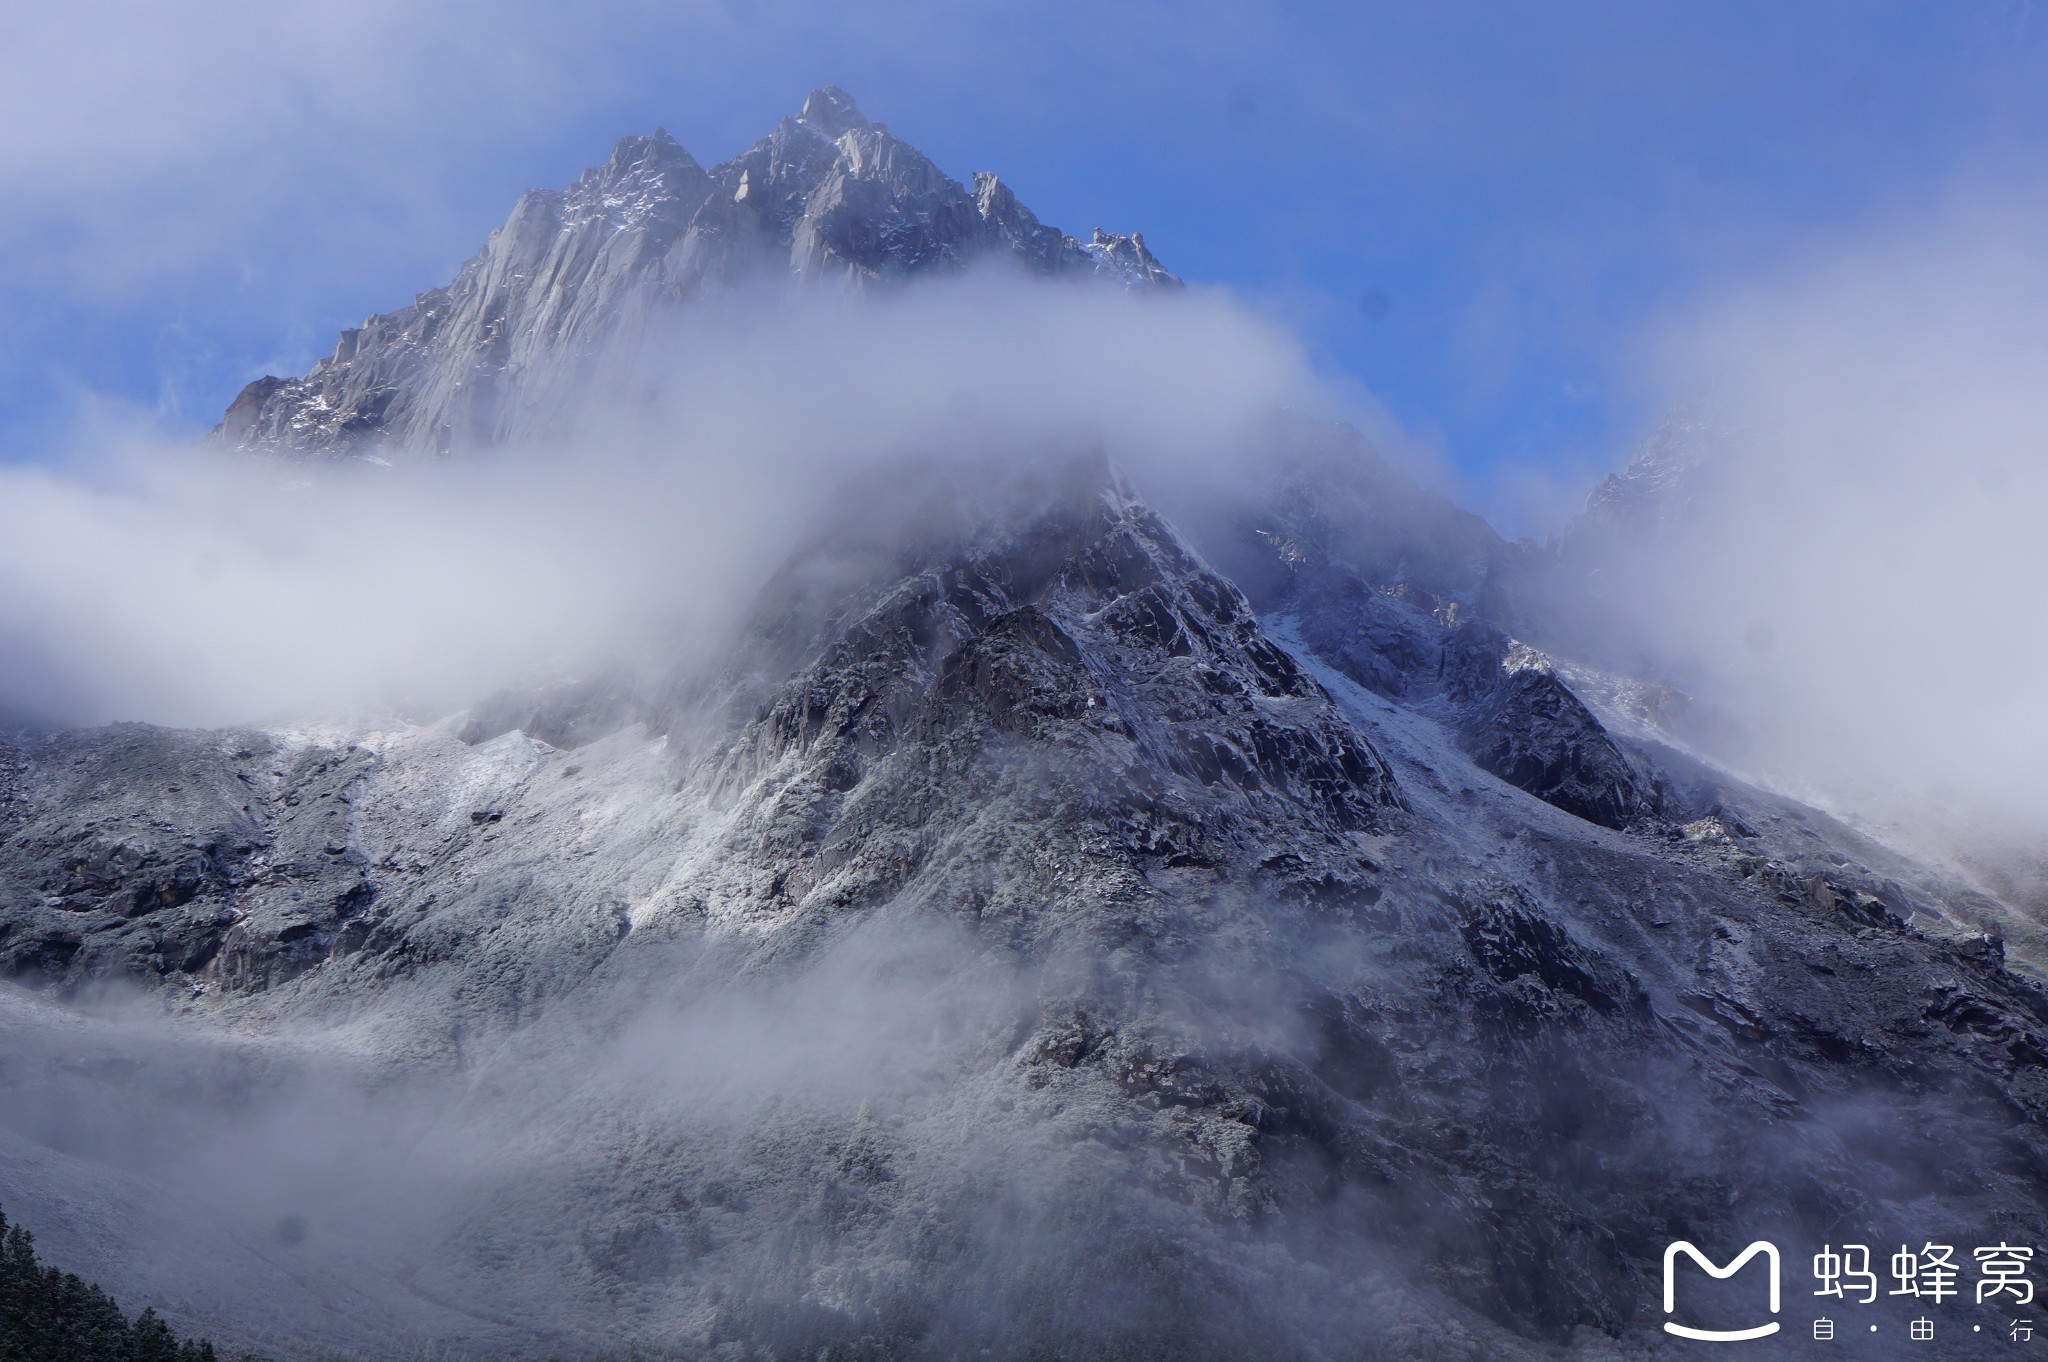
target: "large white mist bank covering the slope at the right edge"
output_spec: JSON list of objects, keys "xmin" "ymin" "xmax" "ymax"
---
[{"xmin": 1518, "ymin": 215, "xmax": 2048, "ymax": 933}]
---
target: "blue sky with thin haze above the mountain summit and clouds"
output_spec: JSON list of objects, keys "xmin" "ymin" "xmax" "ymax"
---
[{"xmin": 0, "ymin": 0, "xmax": 2048, "ymax": 528}]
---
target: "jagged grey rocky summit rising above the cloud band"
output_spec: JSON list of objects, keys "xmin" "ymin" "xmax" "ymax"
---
[{"xmin": 217, "ymin": 86, "xmax": 1180, "ymax": 459}]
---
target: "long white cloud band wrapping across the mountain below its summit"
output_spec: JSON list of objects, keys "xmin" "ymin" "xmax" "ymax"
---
[{"xmin": 0, "ymin": 279, "xmax": 1319, "ymax": 723}]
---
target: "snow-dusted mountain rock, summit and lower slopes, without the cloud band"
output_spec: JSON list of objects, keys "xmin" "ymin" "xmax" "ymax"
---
[{"xmin": 0, "ymin": 90, "xmax": 2048, "ymax": 1362}]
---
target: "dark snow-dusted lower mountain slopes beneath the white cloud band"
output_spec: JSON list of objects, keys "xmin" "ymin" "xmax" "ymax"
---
[{"xmin": 0, "ymin": 450, "xmax": 2048, "ymax": 1358}]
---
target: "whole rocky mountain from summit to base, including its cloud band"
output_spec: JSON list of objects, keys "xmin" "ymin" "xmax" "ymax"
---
[{"xmin": 0, "ymin": 88, "xmax": 2048, "ymax": 1362}]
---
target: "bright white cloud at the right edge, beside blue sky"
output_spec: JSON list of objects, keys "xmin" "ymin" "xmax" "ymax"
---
[{"xmin": 1605, "ymin": 195, "xmax": 2048, "ymax": 844}]
